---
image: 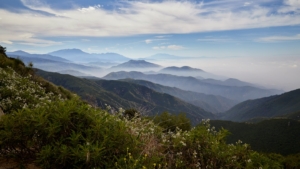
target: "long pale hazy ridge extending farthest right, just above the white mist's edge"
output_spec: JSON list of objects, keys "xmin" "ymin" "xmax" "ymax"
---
[{"xmin": 103, "ymin": 71, "xmax": 280, "ymax": 102}]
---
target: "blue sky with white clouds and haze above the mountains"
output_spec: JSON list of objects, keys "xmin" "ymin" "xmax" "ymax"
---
[{"xmin": 0, "ymin": 0, "xmax": 300, "ymax": 91}]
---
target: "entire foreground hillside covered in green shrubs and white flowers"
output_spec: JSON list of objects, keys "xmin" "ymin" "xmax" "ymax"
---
[{"xmin": 0, "ymin": 46, "xmax": 294, "ymax": 169}]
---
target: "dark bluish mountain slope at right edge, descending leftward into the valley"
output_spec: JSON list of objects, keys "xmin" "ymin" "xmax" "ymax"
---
[{"xmin": 222, "ymin": 89, "xmax": 300, "ymax": 121}]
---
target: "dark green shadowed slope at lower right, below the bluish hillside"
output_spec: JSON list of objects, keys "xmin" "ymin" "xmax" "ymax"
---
[{"xmin": 210, "ymin": 119, "xmax": 300, "ymax": 155}]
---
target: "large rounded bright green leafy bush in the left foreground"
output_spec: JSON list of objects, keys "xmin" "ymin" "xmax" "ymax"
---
[{"xmin": 0, "ymin": 100, "xmax": 144, "ymax": 168}]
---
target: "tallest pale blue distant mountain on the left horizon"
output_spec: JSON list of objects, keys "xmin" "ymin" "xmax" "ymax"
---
[{"xmin": 49, "ymin": 49, "xmax": 129, "ymax": 63}]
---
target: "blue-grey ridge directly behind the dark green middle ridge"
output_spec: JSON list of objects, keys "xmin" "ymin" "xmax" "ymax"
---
[{"xmin": 124, "ymin": 79, "xmax": 237, "ymax": 113}]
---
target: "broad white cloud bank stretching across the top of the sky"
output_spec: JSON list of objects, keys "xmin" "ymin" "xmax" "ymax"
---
[{"xmin": 0, "ymin": 0, "xmax": 300, "ymax": 45}]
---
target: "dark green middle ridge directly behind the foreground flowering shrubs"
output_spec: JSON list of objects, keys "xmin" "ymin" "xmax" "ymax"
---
[{"xmin": 37, "ymin": 70, "xmax": 214, "ymax": 124}]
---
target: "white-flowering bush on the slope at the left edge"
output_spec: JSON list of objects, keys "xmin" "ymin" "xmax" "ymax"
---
[{"xmin": 0, "ymin": 68, "xmax": 63, "ymax": 113}]
